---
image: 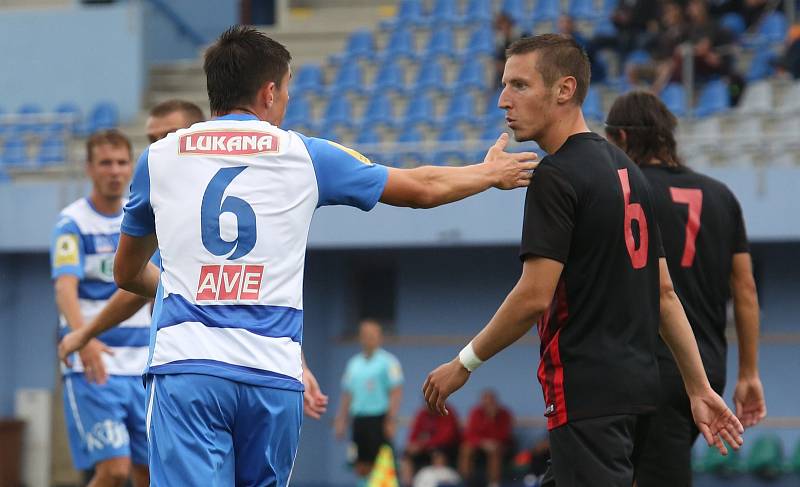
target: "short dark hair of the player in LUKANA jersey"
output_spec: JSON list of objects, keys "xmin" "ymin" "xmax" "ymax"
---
[{"xmin": 203, "ymin": 25, "xmax": 292, "ymax": 114}]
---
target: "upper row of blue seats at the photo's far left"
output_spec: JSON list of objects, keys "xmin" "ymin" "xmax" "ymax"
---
[{"xmin": 0, "ymin": 102, "xmax": 119, "ymax": 137}]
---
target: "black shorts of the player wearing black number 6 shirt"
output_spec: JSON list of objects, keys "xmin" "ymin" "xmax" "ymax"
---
[{"xmin": 542, "ymin": 414, "xmax": 651, "ymax": 487}]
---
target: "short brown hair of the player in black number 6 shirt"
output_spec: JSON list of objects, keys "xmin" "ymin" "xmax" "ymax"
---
[{"xmin": 506, "ymin": 34, "xmax": 591, "ymax": 106}]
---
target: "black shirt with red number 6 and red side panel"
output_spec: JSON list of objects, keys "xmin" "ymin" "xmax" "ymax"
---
[{"xmin": 520, "ymin": 132, "xmax": 663, "ymax": 429}]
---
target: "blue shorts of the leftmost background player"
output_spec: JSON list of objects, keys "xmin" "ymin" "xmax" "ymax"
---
[{"xmin": 64, "ymin": 374, "xmax": 147, "ymax": 470}]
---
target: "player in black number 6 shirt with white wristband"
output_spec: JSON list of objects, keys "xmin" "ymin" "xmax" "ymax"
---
[{"xmin": 423, "ymin": 34, "xmax": 742, "ymax": 487}]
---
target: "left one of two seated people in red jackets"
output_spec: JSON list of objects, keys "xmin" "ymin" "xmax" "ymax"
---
[{"xmin": 400, "ymin": 404, "xmax": 461, "ymax": 485}]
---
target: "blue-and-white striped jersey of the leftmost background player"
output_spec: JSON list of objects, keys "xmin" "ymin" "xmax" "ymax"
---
[{"xmin": 50, "ymin": 198, "xmax": 150, "ymax": 375}]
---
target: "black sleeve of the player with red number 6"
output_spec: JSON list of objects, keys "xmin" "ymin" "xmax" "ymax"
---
[{"xmin": 520, "ymin": 160, "xmax": 578, "ymax": 263}]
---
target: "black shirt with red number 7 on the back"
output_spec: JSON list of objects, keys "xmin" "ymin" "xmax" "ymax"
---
[{"xmin": 642, "ymin": 165, "xmax": 750, "ymax": 393}]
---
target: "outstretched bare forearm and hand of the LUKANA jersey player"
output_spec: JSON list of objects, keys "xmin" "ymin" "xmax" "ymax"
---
[{"xmin": 380, "ymin": 134, "xmax": 537, "ymax": 208}]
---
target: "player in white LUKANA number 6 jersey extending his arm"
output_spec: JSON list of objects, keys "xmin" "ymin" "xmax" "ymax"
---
[{"xmin": 114, "ymin": 27, "xmax": 535, "ymax": 486}]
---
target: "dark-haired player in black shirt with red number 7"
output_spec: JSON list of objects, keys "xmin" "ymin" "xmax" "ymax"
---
[{"xmin": 606, "ymin": 92, "xmax": 766, "ymax": 487}]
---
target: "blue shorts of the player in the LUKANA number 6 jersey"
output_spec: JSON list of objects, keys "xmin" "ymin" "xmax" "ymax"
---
[{"xmin": 147, "ymin": 374, "xmax": 303, "ymax": 487}]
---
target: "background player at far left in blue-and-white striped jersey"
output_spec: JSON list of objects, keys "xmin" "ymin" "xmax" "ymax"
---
[{"xmin": 52, "ymin": 131, "xmax": 150, "ymax": 487}]
